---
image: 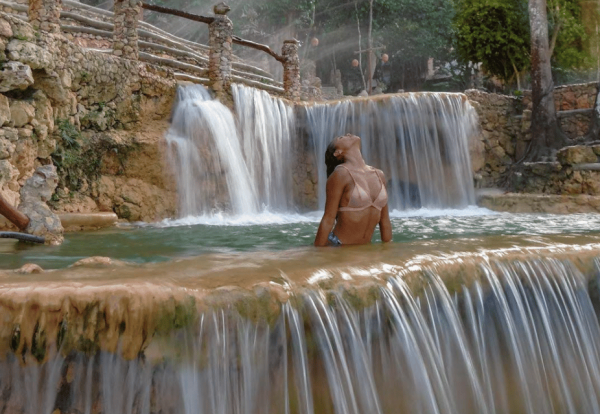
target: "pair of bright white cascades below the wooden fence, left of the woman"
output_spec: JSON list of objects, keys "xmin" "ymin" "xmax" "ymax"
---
[{"xmin": 166, "ymin": 85, "xmax": 294, "ymax": 217}]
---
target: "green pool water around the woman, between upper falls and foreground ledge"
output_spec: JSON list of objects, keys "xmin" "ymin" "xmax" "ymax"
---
[{"xmin": 0, "ymin": 209, "xmax": 600, "ymax": 269}]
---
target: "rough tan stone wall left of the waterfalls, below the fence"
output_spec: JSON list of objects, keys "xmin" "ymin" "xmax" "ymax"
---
[{"xmin": 0, "ymin": 13, "xmax": 176, "ymax": 230}]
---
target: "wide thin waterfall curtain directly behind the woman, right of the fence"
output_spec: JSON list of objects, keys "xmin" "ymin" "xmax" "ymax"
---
[{"xmin": 305, "ymin": 93, "xmax": 477, "ymax": 210}]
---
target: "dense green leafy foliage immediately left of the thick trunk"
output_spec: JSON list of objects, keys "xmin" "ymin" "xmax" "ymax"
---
[{"xmin": 454, "ymin": 0, "xmax": 531, "ymax": 81}]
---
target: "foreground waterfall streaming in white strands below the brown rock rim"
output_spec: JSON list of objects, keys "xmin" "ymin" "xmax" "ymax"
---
[{"xmin": 0, "ymin": 258, "xmax": 600, "ymax": 414}]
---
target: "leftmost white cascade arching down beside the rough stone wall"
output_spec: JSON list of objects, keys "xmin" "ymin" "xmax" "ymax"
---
[{"xmin": 166, "ymin": 86, "xmax": 258, "ymax": 216}]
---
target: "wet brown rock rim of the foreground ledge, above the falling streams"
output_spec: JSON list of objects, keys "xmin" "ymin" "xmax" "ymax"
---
[{"xmin": 0, "ymin": 236, "xmax": 600, "ymax": 362}]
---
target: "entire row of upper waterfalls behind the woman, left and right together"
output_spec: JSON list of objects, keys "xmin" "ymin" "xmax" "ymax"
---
[{"xmin": 167, "ymin": 85, "xmax": 477, "ymax": 216}]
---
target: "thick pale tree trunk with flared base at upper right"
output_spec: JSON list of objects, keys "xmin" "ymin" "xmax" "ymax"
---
[{"xmin": 526, "ymin": 0, "xmax": 567, "ymax": 161}]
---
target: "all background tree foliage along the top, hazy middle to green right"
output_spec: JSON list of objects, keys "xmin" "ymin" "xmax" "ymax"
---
[{"xmin": 84, "ymin": 0, "xmax": 591, "ymax": 89}]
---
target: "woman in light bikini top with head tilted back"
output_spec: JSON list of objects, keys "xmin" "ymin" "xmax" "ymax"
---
[{"xmin": 315, "ymin": 134, "xmax": 392, "ymax": 246}]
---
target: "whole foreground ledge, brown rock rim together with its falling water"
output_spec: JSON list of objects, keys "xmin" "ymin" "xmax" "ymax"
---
[{"xmin": 0, "ymin": 236, "xmax": 600, "ymax": 413}]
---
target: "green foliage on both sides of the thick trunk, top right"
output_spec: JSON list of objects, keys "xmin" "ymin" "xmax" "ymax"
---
[{"xmin": 454, "ymin": 0, "xmax": 590, "ymax": 86}]
